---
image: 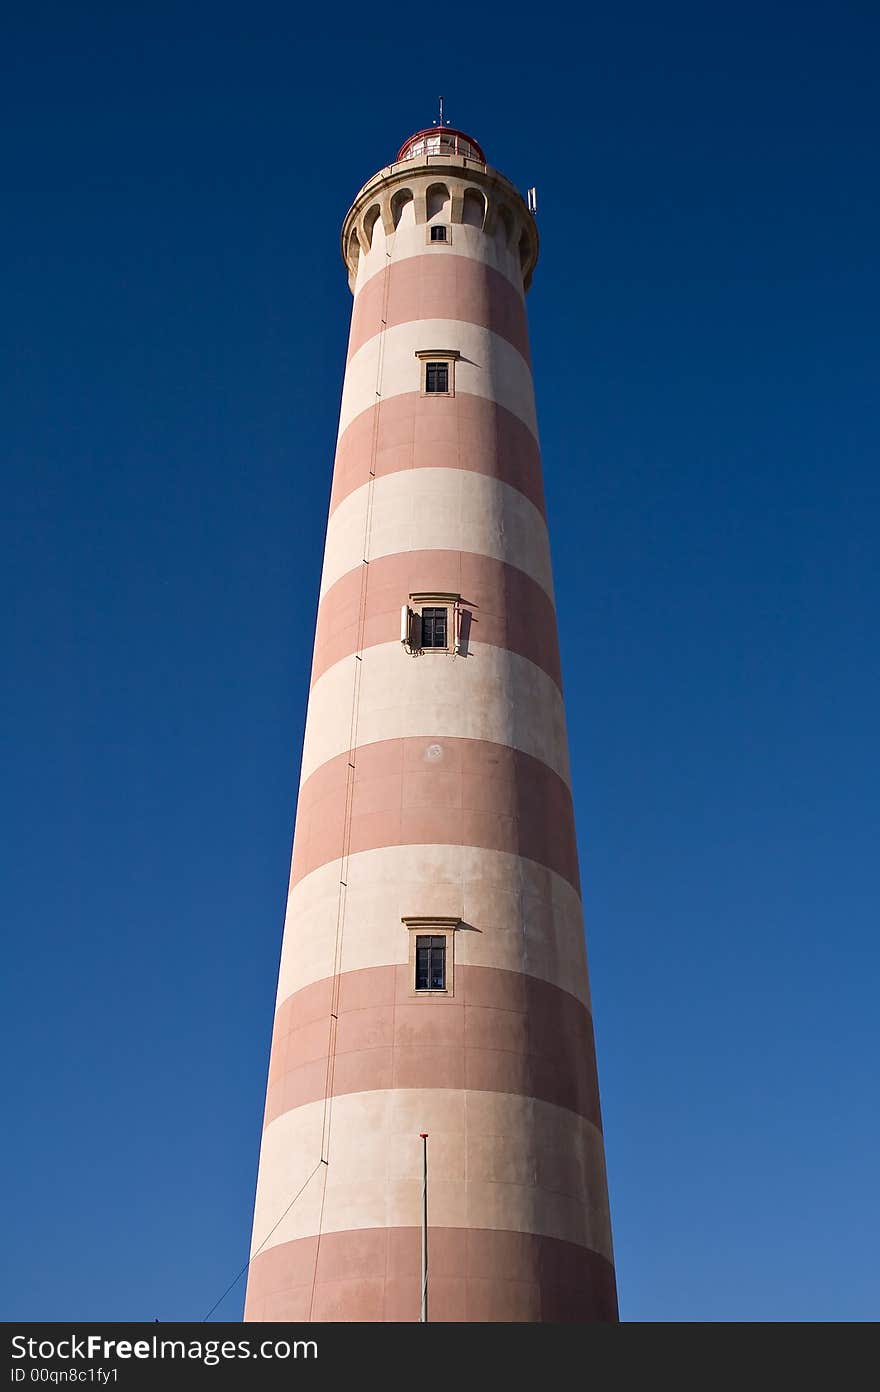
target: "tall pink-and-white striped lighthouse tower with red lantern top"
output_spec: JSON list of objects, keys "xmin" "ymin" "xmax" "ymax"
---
[{"xmin": 245, "ymin": 127, "xmax": 617, "ymax": 1321}]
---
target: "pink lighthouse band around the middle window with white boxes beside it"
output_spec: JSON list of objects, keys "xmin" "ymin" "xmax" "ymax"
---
[{"xmin": 312, "ymin": 551, "xmax": 563, "ymax": 688}]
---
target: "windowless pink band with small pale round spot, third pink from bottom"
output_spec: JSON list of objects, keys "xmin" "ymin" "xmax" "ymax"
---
[{"xmin": 291, "ymin": 736, "xmax": 579, "ymax": 889}]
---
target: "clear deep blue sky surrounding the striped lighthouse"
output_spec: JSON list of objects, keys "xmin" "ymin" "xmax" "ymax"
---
[{"xmin": 0, "ymin": 4, "xmax": 880, "ymax": 1321}]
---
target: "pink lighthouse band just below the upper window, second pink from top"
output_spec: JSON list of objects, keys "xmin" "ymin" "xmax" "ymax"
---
[{"xmin": 330, "ymin": 391, "xmax": 544, "ymax": 516}]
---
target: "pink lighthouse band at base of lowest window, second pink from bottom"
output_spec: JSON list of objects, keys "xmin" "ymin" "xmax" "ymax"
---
[{"xmin": 263, "ymin": 968, "xmax": 602, "ymax": 1128}]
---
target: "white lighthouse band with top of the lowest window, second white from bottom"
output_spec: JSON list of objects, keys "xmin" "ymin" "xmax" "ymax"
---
[{"xmin": 277, "ymin": 845, "xmax": 590, "ymax": 1008}]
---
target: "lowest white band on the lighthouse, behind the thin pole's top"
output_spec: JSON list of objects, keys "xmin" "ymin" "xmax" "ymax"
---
[{"xmin": 251, "ymin": 1089, "xmax": 611, "ymax": 1260}]
